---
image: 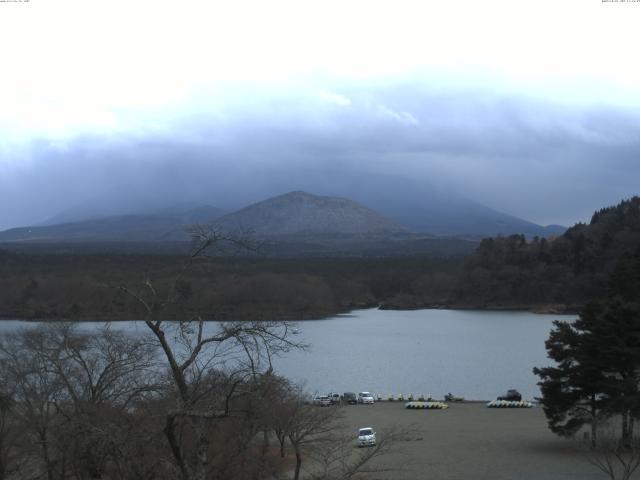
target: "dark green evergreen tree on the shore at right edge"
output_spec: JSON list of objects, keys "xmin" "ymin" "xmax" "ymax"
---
[{"xmin": 534, "ymin": 251, "xmax": 640, "ymax": 446}]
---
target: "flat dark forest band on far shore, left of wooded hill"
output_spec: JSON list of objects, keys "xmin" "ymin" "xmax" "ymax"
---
[{"xmin": 0, "ymin": 252, "xmax": 459, "ymax": 320}]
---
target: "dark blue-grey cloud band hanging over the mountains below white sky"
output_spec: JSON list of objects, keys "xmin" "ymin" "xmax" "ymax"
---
[{"xmin": 0, "ymin": 85, "xmax": 640, "ymax": 232}]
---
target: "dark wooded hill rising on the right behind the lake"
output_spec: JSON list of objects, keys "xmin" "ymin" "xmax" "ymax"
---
[{"xmin": 452, "ymin": 197, "xmax": 640, "ymax": 310}]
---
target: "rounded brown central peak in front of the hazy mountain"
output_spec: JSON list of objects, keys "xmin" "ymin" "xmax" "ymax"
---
[{"xmin": 216, "ymin": 191, "xmax": 407, "ymax": 236}]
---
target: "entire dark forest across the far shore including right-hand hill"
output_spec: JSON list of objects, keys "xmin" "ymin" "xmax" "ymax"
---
[{"xmin": 0, "ymin": 197, "xmax": 640, "ymax": 319}]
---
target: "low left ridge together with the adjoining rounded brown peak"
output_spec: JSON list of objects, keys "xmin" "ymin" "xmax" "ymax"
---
[{"xmin": 0, "ymin": 191, "xmax": 408, "ymax": 243}]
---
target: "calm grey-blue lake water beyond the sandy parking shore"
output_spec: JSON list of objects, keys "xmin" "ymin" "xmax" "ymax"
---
[{"xmin": 0, "ymin": 309, "xmax": 575, "ymax": 400}]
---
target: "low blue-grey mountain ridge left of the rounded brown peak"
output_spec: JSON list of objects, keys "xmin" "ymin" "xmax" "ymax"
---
[{"xmin": 0, "ymin": 205, "xmax": 222, "ymax": 243}]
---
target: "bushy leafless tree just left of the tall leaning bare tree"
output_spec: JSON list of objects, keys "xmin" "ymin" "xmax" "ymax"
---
[{"xmin": 39, "ymin": 324, "xmax": 159, "ymax": 478}]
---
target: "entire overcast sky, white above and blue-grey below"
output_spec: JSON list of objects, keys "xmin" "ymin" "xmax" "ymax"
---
[{"xmin": 0, "ymin": 0, "xmax": 640, "ymax": 229}]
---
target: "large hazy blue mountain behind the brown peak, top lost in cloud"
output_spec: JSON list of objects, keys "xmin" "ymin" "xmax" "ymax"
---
[{"xmin": 26, "ymin": 172, "xmax": 565, "ymax": 239}]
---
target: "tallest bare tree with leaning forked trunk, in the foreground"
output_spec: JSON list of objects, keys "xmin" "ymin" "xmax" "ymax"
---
[{"xmin": 112, "ymin": 226, "xmax": 300, "ymax": 480}]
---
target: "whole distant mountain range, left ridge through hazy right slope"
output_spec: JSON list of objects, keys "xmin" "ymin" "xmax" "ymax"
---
[{"xmin": 0, "ymin": 188, "xmax": 563, "ymax": 251}]
